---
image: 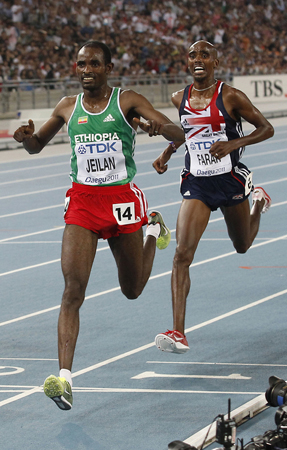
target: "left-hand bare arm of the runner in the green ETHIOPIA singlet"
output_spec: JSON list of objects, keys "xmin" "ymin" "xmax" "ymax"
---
[{"xmin": 13, "ymin": 96, "xmax": 76, "ymax": 154}]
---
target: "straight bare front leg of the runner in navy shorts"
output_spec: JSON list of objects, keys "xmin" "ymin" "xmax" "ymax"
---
[{"xmin": 171, "ymin": 199, "xmax": 211, "ymax": 334}]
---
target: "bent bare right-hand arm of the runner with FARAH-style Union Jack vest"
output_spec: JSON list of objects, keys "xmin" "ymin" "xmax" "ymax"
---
[{"xmin": 209, "ymin": 85, "xmax": 274, "ymax": 159}]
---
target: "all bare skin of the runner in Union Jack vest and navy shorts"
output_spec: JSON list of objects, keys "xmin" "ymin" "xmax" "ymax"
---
[{"xmin": 153, "ymin": 41, "xmax": 274, "ymax": 334}]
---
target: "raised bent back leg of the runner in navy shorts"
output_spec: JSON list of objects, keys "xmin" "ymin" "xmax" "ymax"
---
[{"xmin": 221, "ymin": 198, "xmax": 264, "ymax": 253}]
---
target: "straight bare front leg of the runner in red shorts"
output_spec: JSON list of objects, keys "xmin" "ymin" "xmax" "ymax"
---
[{"xmin": 58, "ymin": 225, "xmax": 98, "ymax": 370}]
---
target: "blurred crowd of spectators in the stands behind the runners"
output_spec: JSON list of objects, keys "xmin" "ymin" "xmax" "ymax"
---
[{"xmin": 0, "ymin": 0, "xmax": 287, "ymax": 84}]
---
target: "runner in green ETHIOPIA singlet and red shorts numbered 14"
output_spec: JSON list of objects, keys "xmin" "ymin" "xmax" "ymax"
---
[{"xmin": 14, "ymin": 41, "xmax": 184, "ymax": 410}]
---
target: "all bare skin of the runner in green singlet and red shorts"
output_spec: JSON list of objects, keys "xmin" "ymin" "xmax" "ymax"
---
[{"xmin": 14, "ymin": 44, "xmax": 183, "ymax": 370}]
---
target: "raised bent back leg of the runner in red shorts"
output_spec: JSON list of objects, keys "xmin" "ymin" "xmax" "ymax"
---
[{"xmin": 108, "ymin": 228, "xmax": 156, "ymax": 299}]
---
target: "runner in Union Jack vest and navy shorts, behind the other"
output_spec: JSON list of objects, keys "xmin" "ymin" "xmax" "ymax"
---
[{"xmin": 153, "ymin": 41, "xmax": 274, "ymax": 353}]
